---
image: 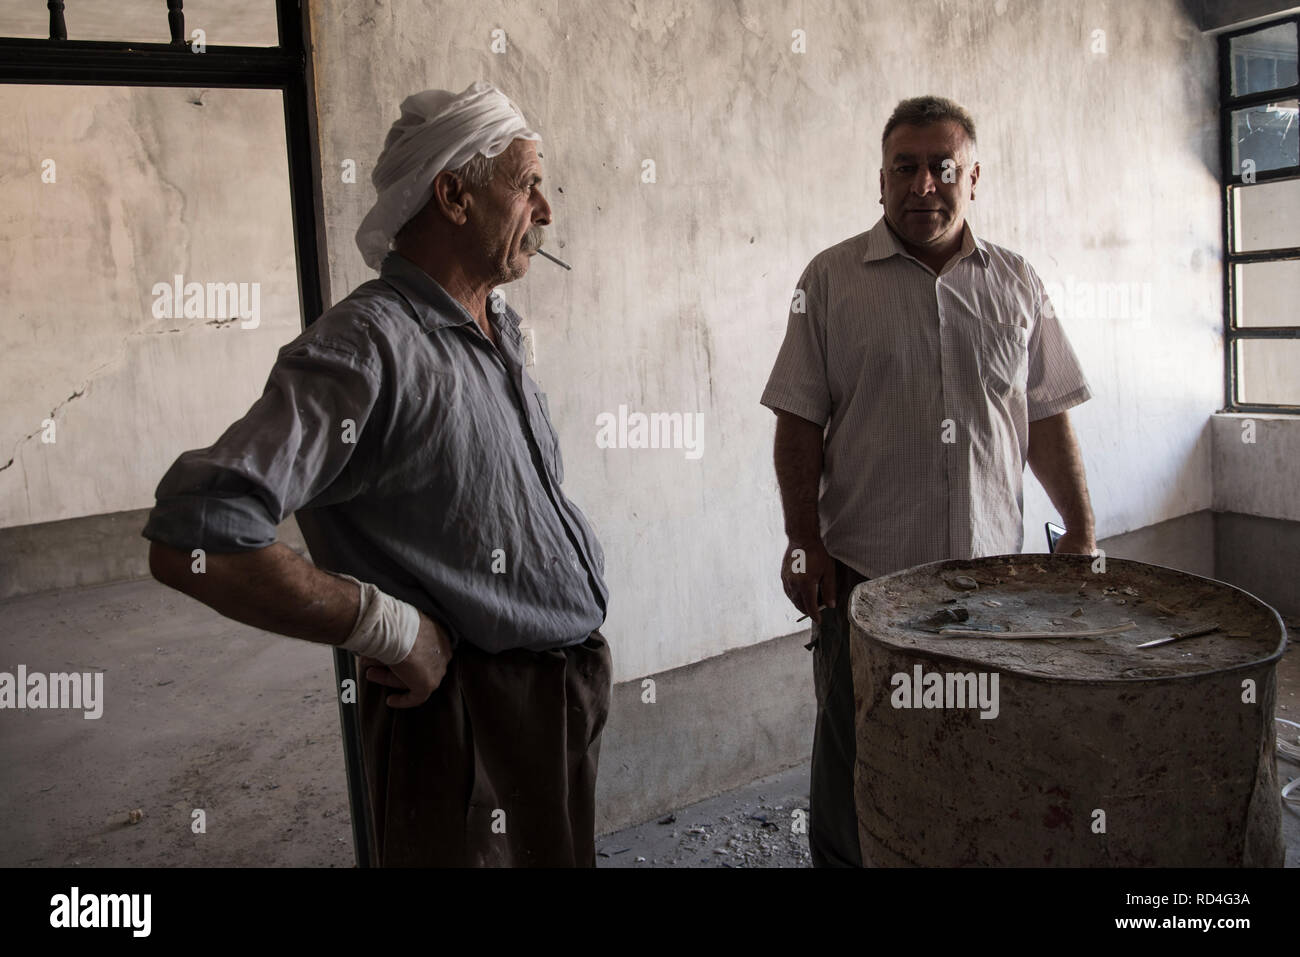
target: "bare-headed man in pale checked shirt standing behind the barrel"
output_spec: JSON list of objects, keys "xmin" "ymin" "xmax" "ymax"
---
[{"xmin": 762, "ymin": 96, "xmax": 1096, "ymax": 867}]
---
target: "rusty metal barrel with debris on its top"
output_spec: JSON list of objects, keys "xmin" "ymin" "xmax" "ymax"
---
[{"xmin": 849, "ymin": 555, "xmax": 1286, "ymax": 867}]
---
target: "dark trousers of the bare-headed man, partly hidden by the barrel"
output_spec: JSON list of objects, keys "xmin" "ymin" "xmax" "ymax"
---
[{"xmin": 809, "ymin": 562, "xmax": 867, "ymax": 867}]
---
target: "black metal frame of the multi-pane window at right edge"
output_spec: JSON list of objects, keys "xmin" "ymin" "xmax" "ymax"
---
[{"xmin": 1218, "ymin": 14, "xmax": 1300, "ymax": 415}]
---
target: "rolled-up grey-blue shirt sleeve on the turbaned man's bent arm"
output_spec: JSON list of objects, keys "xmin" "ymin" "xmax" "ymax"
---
[{"xmin": 143, "ymin": 332, "xmax": 382, "ymax": 553}]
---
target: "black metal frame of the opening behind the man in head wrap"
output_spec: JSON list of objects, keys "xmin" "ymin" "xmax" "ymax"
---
[{"xmin": 0, "ymin": 0, "xmax": 372, "ymax": 867}]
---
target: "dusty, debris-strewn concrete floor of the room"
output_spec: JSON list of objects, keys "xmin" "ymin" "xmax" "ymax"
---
[{"xmin": 0, "ymin": 580, "xmax": 1300, "ymax": 867}]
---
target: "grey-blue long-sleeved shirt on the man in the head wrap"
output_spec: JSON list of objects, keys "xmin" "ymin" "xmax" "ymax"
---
[{"xmin": 143, "ymin": 252, "xmax": 608, "ymax": 653}]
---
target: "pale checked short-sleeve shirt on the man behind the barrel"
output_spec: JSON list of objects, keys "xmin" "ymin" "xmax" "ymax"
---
[{"xmin": 762, "ymin": 217, "xmax": 1092, "ymax": 577}]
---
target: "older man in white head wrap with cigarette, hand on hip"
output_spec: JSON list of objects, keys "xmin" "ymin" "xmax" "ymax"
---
[{"xmin": 144, "ymin": 83, "xmax": 612, "ymax": 866}]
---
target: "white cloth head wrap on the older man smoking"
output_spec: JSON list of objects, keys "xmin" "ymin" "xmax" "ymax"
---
[{"xmin": 356, "ymin": 81, "xmax": 541, "ymax": 269}]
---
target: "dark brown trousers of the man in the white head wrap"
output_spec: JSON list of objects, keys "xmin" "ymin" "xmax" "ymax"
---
[{"xmin": 358, "ymin": 632, "xmax": 612, "ymax": 867}]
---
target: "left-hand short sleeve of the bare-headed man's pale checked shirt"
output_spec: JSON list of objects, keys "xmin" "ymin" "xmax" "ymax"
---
[{"xmin": 761, "ymin": 261, "xmax": 831, "ymax": 425}]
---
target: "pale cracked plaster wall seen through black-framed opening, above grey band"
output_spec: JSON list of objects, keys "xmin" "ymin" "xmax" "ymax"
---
[{"xmin": 0, "ymin": 81, "xmax": 300, "ymax": 527}]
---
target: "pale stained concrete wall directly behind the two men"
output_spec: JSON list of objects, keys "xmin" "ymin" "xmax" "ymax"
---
[{"xmin": 312, "ymin": 0, "xmax": 1222, "ymax": 679}]
